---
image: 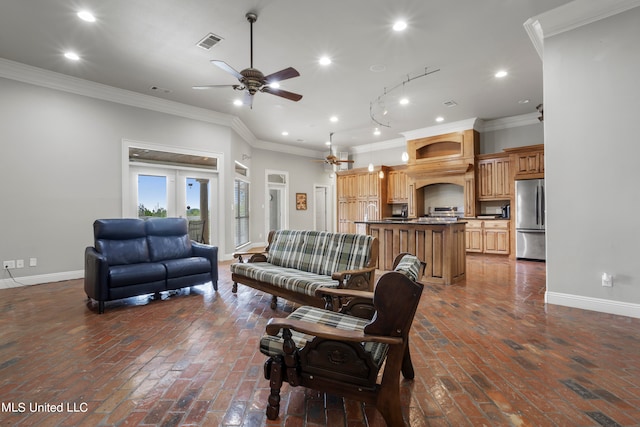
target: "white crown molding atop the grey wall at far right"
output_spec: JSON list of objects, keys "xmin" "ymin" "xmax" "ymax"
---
[{"xmin": 524, "ymin": 0, "xmax": 640, "ymax": 58}]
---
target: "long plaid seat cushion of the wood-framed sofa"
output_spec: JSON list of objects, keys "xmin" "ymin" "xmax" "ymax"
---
[{"xmin": 231, "ymin": 262, "xmax": 338, "ymax": 296}]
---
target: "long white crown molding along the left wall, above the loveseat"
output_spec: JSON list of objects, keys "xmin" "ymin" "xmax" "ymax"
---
[{"xmin": 0, "ymin": 58, "xmax": 256, "ymax": 140}]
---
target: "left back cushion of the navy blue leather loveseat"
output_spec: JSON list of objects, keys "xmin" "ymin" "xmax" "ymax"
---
[{"xmin": 93, "ymin": 218, "xmax": 150, "ymax": 265}]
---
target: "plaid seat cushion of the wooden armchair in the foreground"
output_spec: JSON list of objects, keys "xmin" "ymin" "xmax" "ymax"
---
[{"xmin": 260, "ymin": 306, "xmax": 389, "ymax": 367}]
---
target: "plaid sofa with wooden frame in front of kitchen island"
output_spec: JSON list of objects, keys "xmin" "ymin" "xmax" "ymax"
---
[{"xmin": 231, "ymin": 230, "xmax": 378, "ymax": 309}]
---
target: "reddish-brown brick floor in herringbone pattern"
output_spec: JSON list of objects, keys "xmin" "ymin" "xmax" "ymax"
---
[{"xmin": 0, "ymin": 255, "xmax": 640, "ymax": 427}]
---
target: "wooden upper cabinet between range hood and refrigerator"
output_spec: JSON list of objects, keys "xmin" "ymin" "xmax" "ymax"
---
[{"xmin": 476, "ymin": 153, "xmax": 513, "ymax": 201}]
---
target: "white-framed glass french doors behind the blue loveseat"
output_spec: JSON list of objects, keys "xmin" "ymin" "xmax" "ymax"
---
[{"xmin": 129, "ymin": 165, "xmax": 218, "ymax": 244}]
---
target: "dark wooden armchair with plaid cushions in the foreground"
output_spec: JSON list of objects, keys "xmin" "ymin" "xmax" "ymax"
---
[{"xmin": 260, "ymin": 261, "xmax": 424, "ymax": 427}]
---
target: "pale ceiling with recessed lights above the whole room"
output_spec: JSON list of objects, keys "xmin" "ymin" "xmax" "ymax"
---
[{"xmin": 0, "ymin": 0, "xmax": 569, "ymax": 150}]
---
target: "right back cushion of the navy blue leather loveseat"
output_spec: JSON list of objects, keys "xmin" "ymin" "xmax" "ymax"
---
[{"xmin": 145, "ymin": 218, "xmax": 192, "ymax": 261}]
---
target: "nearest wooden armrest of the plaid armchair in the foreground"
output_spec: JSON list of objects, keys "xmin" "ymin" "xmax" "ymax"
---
[{"xmin": 266, "ymin": 318, "xmax": 402, "ymax": 345}]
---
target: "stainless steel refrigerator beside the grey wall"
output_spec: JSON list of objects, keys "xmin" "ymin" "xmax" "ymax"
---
[{"xmin": 516, "ymin": 179, "xmax": 546, "ymax": 260}]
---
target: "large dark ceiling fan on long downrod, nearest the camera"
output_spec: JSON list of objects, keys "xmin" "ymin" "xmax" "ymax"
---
[{"xmin": 193, "ymin": 12, "xmax": 302, "ymax": 106}]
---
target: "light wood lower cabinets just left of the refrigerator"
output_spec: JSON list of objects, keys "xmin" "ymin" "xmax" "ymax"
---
[{"xmin": 465, "ymin": 219, "xmax": 511, "ymax": 255}]
